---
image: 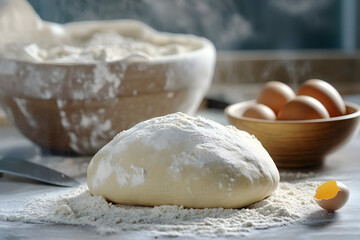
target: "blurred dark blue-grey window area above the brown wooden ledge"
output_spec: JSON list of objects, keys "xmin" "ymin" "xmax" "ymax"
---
[{"xmin": 29, "ymin": 0, "xmax": 360, "ymax": 51}]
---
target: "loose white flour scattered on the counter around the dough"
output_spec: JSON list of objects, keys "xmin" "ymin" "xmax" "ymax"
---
[{"xmin": 0, "ymin": 181, "xmax": 318, "ymax": 237}]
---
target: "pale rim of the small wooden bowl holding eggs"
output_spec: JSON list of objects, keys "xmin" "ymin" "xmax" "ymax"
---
[{"xmin": 224, "ymin": 100, "xmax": 360, "ymax": 124}]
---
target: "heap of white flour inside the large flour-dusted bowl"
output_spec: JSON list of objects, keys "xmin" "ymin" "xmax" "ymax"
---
[{"xmin": 24, "ymin": 31, "xmax": 198, "ymax": 63}]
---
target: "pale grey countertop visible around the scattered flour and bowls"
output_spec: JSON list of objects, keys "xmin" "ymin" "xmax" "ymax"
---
[{"xmin": 0, "ymin": 93, "xmax": 360, "ymax": 240}]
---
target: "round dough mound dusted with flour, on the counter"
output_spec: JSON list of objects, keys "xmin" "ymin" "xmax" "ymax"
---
[{"xmin": 87, "ymin": 113, "xmax": 279, "ymax": 208}]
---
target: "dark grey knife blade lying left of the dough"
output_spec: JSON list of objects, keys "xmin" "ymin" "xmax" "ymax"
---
[{"xmin": 0, "ymin": 157, "xmax": 80, "ymax": 187}]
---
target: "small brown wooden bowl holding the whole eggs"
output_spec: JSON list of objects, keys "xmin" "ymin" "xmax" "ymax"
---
[{"xmin": 225, "ymin": 101, "xmax": 360, "ymax": 167}]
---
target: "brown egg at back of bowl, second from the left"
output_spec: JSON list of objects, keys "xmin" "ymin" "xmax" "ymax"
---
[{"xmin": 257, "ymin": 81, "xmax": 295, "ymax": 115}]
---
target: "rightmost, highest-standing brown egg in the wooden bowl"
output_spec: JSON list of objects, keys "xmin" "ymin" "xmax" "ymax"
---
[{"xmin": 298, "ymin": 79, "xmax": 346, "ymax": 117}]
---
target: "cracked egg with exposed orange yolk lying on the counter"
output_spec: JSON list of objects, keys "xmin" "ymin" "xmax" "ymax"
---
[{"xmin": 315, "ymin": 180, "xmax": 350, "ymax": 211}]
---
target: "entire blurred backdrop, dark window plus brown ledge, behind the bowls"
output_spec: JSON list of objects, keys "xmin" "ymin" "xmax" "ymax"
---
[{"xmin": 21, "ymin": 0, "xmax": 360, "ymax": 102}]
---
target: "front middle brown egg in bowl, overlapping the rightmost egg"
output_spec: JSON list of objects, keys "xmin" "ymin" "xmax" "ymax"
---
[{"xmin": 277, "ymin": 96, "xmax": 330, "ymax": 120}]
